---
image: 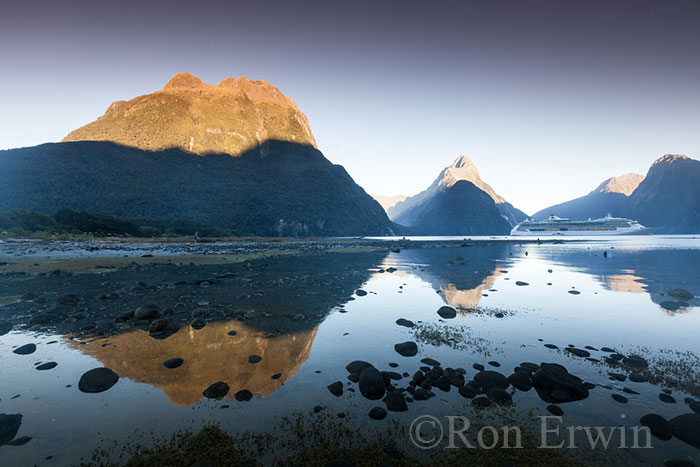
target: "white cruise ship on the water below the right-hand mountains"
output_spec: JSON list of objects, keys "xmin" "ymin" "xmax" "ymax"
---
[{"xmin": 510, "ymin": 214, "xmax": 655, "ymax": 236}]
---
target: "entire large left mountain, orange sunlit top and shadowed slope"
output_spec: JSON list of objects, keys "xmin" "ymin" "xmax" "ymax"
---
[{"xmin": 0, "ymin": 73, "xmax": 395, "ymax": 236}]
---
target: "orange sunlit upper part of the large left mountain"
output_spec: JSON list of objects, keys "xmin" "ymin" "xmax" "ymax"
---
[{"xmin": 63, "ymin": 73, "xmax": 316, "ymax": 155}]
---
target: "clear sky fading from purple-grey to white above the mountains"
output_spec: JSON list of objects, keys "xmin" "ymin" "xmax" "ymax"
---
[{"xmin": 0, "ymin": 0, "xmax": 700, "ymax": 214}]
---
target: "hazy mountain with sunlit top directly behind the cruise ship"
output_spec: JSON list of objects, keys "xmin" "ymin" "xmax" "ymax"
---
[{"xmin": 532, "ymin": 173, "xmax": 644, "ymax": 220}]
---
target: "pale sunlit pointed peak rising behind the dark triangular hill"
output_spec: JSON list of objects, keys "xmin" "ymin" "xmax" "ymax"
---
[{"xmin": 388, "ymin": 155, "xmax": 527, "ymax": 227}]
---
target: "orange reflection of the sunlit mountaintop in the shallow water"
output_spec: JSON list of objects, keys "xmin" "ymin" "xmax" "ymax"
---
[{"xmin": 68, "ymin": 321, "xmax": 317, "ymax": 406}]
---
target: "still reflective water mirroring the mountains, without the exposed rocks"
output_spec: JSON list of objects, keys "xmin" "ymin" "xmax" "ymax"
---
[{"xmin": 0, "ymin": 236, "xmax": 700, "ymax": 465}]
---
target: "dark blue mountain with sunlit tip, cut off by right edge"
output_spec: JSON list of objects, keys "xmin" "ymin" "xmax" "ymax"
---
[{"xmin": 625, "ymin": 154, "xmax": 700, "ymax": 233}]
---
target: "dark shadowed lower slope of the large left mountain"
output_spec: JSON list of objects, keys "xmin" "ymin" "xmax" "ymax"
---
[{"xmin": 0, "ymin": 140, "xmax": 393, "ymax": 236}]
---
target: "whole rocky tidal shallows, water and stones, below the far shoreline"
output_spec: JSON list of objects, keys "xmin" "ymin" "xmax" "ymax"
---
[{"xmin": 0, "ymin": 236, "xmax": 700, "ymax": 465}]
